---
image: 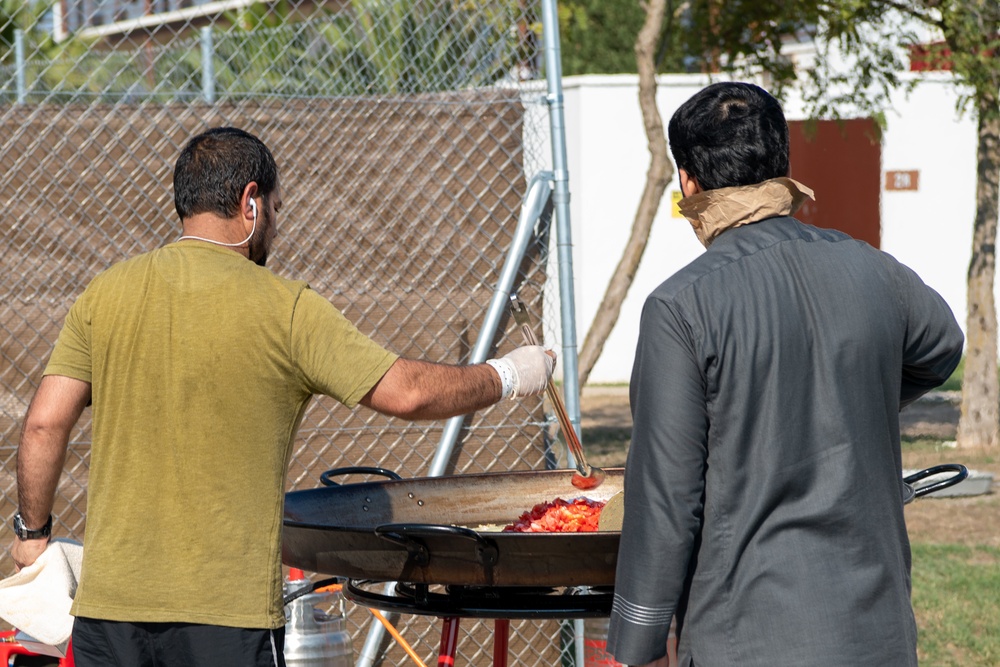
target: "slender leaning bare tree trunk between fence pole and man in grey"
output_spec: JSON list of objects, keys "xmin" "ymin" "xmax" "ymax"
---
[{"xmin": 579, "ymin": 0, "xmax": 674, "ymax": 386}]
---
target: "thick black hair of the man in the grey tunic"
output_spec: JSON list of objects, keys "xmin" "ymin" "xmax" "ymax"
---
[{"xmin": 667, "ymin": 82, "xmax": 788, "ymax": 190}]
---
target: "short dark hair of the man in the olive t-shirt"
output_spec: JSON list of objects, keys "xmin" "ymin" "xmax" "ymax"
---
[{"xmin": 174, "ymin": 127, "xmax": 278, "ymax": 220}]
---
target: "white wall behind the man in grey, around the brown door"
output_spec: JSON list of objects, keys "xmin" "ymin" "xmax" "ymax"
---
[{"xmin": 563, "ymin": 70, "xmax": 976, "ymax": 383}]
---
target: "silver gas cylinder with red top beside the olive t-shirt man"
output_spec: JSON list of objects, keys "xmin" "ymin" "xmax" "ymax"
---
[{"xmin": 284, "ymin": 568, "xmax": 354, "ymax": 667}]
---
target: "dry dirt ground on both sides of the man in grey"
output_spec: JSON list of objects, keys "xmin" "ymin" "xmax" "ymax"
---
[{"xmin": 580, "ymin": 386, "xmax": 1000, "ymax": 548}]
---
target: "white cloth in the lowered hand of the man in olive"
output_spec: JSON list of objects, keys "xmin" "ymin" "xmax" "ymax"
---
[{"xmin": 0, "ymin": 539, "xmax": 83, "ymax": 645}]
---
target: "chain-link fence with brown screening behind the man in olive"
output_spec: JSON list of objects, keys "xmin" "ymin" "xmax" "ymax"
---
[{"xmin": 0, "ymin": 0, "xmax": 584, "ymax": 665}]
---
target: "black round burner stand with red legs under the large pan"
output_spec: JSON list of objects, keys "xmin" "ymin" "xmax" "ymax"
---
[{"xmin": 344, "ymin": 579, "xmax": 614, "ymax": 667}]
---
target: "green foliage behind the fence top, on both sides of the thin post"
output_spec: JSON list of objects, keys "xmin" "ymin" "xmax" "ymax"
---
[{"xmin": 0, "ymin": 0, "xmax": 534, "ymax": 103}]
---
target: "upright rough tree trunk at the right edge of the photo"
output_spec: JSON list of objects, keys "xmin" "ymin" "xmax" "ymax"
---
[{"xmin": 958, "ymin": 92, "xmax": 1000, "ymax": 448}]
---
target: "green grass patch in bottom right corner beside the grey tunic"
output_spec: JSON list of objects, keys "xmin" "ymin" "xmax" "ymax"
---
[{"xmin": 912, "ymin": 544, "xmax": 1000, "ymax": 667}]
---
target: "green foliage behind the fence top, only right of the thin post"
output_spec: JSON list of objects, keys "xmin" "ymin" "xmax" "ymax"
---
[{"xmin": 215, "ymin": 0, "xmax": 523, "ymax": 96}]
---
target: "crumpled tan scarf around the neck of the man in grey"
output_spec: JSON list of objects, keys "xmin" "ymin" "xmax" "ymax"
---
[{"xmin": 677, "ymin": 177, "xmax": 816, "ymax": 248}]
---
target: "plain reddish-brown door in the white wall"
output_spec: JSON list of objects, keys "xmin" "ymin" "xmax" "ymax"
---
[{"xmin": 788, "ymin": 118, "xmax": 882, "ymax": 248}]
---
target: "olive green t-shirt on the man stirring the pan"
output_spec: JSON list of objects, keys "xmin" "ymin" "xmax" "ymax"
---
[{"xmin": 45, "ymin": 241, "xmax": 397, "ymax": 628}]
